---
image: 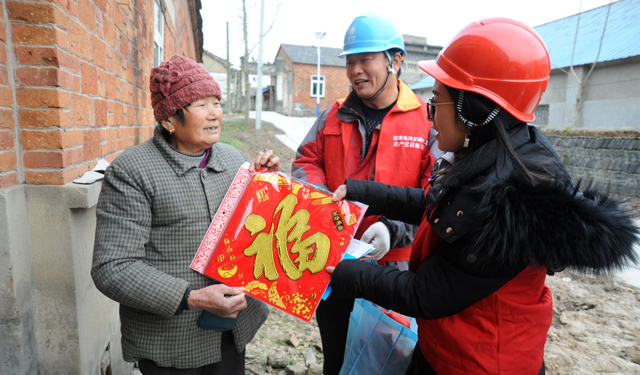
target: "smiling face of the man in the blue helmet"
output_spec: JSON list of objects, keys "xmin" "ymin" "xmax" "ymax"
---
[{"xmin": 347, "ymin": 52, "xmax": 389, "ymax": 98}]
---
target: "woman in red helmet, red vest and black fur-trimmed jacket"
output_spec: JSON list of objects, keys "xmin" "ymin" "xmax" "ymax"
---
[{"xmin": 327, "ymin": 18, "xmax": 639, "ymax": 375}]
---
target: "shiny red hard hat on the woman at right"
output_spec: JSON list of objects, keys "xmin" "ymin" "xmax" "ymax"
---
[{"xmin": 418, "ymin": 18, "xmax": 551, "ymax": 122}]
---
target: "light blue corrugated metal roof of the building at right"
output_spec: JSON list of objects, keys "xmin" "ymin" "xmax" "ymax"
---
[{"xmin": 534, "ymin": 0, "xmax": 640, "ymax": 69}]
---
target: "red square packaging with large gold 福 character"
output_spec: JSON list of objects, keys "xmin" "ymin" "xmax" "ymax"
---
[{"xmin": 191, "ymin": 163, "xmax": 367, "ymax": 322}]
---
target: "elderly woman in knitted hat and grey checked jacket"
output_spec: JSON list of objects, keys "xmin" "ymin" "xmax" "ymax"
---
[{"xmin": 91, "ymin": 55, "xmax": 280, "ymax": 375}]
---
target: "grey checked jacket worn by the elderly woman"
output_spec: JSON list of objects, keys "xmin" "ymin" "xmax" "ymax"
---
[{"xmin": 91, "ymin": 128, "xmax": 269, "ymax": 368}]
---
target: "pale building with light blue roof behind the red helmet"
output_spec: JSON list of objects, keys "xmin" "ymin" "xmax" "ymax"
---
[{"xmin": 411, "ymin": 0, "xmax": 640, "ymax": 130}]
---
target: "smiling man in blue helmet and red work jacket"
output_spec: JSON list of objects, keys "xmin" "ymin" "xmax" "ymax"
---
[{"xmin": 292, "ymin": 13, "xmax": 441, "ymax": 375}]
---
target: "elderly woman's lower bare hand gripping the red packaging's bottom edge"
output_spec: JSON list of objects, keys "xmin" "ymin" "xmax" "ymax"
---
[{"xmin": 188, "ymin": 284, "xmax": 247, "ymax": 318}]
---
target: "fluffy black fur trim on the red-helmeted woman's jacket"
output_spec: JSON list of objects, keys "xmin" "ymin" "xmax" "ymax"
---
[{"xmin": 473, "ymin": 179, "xmax": 640, "ymax": 274}]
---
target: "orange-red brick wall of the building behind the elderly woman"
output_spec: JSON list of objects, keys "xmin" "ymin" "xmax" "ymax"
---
[{"xmin": 0, "ymin": 0, "xmax": 202, "ymax": 188}]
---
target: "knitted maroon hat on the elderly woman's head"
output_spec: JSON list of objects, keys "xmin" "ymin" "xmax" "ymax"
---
[{"xmin": 149, "ymin": 55, "xmax": 222, "ymax": 122}]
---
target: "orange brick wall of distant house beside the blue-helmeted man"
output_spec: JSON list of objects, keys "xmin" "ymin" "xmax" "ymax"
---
[{"xmin": 292, "ymin": 64, "xmax": 349, "ymax": 116}]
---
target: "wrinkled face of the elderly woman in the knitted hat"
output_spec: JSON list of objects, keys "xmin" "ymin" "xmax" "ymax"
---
[{"xmin": 163, "ymin": 96, "xmax": 222, "ymax": 155}]
